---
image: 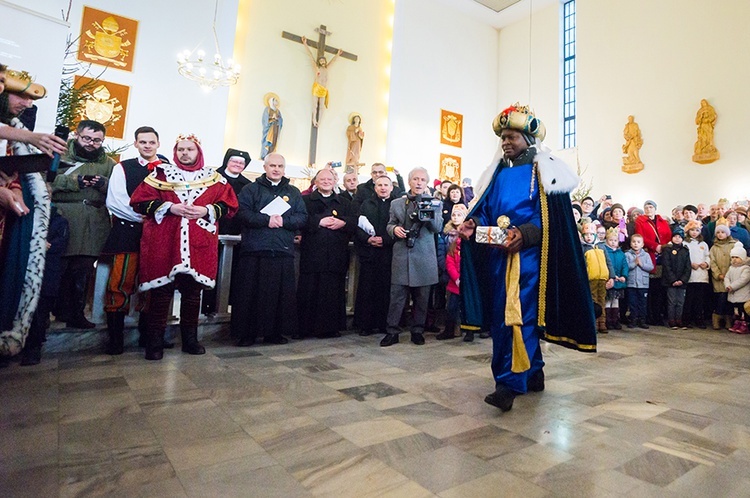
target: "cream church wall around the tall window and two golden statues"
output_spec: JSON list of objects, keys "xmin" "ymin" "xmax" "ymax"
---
[{"xmin": 498, "ymin": 0, "xmax": 750, "ymax": 215}]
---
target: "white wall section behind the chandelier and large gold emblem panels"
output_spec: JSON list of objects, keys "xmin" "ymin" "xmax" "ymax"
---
[{"xmin": 5, "ymin": 0, "xmax": 238, "ymax": 165}]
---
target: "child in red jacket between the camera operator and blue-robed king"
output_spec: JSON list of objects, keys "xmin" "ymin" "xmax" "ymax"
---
[{"xmin": 435, "ymin": 204, "xmax": 474, "ymax": 342}]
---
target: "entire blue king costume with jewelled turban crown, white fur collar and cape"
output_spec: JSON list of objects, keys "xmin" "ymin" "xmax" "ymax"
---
[{"xmin": 461, "ymin": 104, "xmax": 596, "ymax": 411}]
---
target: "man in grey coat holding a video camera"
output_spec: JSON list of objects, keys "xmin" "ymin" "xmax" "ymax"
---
[{"xmin": 380, "ymin": 168, "xmax": 443, "ymax": 347}]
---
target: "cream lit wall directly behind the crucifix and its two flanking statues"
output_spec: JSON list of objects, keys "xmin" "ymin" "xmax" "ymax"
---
[{"xmin": 225, "ymin": 0, "xmax": 392, "ymax": 173}]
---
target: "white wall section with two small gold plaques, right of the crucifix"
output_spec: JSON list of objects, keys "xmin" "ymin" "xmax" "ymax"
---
[{"xmin": 387, "ymin": 0, "xmax": 498, "ymax": 185}]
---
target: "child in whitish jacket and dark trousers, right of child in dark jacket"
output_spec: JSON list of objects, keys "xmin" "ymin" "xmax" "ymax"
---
[{"xmin": 682, "ymin": 220, "xmax": 711, "ymax": 329}]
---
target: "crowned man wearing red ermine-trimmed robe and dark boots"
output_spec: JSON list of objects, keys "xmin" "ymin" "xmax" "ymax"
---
[{"xmin": 130, "ymin": 134, "xmax": 237, "ymax": 360}]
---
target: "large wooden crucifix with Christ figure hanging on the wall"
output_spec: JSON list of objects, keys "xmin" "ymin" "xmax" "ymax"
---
[{"xmin": 281, "ymin": 24, "xmax": 357, "ymax": 165}]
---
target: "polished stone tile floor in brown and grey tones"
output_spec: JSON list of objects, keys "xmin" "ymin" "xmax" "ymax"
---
[{"xmin": 0, "ymin": 328, "xmax": 750, "ymax": 498}]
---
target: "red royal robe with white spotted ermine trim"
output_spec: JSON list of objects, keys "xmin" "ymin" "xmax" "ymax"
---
[{"xmin": 130, "ymin": 165, "xmax": 237, "ymax": 291}]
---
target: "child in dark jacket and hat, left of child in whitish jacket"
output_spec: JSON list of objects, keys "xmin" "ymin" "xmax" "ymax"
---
[{"xmin": 661, "ymin": 227, "xmax": 691, "ymax": 330}]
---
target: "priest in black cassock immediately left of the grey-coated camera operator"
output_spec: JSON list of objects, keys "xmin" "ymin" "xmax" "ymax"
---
[{"xmin": 354, "ymin": 176, "xmax": 395, "ymax": 336}]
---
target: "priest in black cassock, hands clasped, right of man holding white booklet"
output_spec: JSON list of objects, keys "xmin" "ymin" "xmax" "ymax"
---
[{"xmin": 293, "ymin": 169, "xmax": 357, "ymax": 339}]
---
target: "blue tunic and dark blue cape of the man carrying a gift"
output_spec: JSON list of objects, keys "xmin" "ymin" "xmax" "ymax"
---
[{"xmin": 461, "ymin": 148, "xmax": 596, "ymax": 393}]
